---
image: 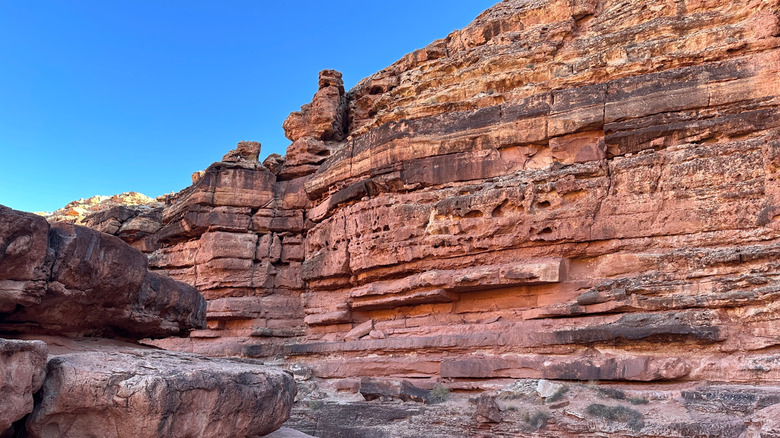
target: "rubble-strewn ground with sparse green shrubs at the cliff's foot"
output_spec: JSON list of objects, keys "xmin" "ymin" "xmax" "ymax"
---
[{"xmin": 288, "ymin": 380, "xmax": 778, "ymax": 438}]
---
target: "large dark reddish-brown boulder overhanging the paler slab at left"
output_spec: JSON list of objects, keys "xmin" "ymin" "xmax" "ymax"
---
[{"xmin": 0, "ymin": 206, "xmax": 206, "ymax": 339}]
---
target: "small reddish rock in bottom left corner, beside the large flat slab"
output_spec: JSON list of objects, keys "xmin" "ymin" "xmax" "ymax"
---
[{"xmin": 0, "ymin": 339, "xmax": 48, "ymax": 433}]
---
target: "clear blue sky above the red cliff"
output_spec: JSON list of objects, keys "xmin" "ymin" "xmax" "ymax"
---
[{"xmin": 0, "ymin": 0, "xmax": 497, "ymax": 211}]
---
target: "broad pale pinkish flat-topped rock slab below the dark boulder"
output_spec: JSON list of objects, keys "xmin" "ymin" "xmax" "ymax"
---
[{"xmin": 27, "ymin": 348, "xmax": 296, "ymax": 438}]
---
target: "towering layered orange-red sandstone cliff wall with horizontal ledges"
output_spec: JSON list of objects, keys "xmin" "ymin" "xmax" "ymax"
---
[{"xmin": 68, "ymin": 0, "xmax": 780, "ymax": 436}]
